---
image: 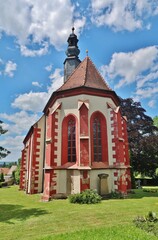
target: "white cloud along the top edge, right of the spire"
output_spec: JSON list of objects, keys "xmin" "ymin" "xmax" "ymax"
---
[{"xmin": 91, "ymin": 0, "xmax": 158, "ymax": 31}]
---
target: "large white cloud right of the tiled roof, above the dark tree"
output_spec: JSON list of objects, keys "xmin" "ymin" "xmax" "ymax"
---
[{"xmin": 101, "ymin": 46, "xmax": 158, "ymax": 88}]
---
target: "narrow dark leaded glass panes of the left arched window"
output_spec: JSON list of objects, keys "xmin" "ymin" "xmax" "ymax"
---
[{"xmin": 67, "ymin": 119, "xmax": 76, "ymax": 162}]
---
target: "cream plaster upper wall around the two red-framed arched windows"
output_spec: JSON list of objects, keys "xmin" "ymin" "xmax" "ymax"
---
[{"xmin": 52, "ymin": 94, "xmax": 116, "ymax": 165}]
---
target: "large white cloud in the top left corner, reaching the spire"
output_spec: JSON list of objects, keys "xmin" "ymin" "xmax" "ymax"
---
[{"xmin": 0, "ymin": 0, "xmax": 85, "ymax": 56}]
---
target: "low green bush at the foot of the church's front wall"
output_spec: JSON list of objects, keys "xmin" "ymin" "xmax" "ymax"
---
[{"xmin": 69, "ymin": 189, "xmax": 101, "ymax": 204}]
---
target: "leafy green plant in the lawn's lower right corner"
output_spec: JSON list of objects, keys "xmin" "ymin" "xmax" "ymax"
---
[{"xmin": 134, "ymin": 211, "xmax": 158, "ymax": 236}]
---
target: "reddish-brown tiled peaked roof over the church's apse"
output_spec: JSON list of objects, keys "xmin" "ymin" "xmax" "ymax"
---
[{"xmin": 57, "ymin": 56, "xmax": 111, "ymax": 91}]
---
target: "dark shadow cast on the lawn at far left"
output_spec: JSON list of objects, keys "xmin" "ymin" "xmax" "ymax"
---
[{"xmin": 0, "ymin": 204, "xmax": 48, "ymax": 224}]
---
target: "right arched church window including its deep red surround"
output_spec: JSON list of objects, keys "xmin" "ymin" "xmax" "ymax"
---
[{"xmin": 91, "ymin": 111, "xmax": 108, "ymax": 163}]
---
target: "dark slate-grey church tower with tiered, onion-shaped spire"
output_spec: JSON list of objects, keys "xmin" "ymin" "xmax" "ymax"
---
[{"xmin": 64, "ymin": 27, "xmax": 81, "ymax": 82}]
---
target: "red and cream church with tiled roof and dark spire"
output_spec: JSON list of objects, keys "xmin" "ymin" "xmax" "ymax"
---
[{"xmin": 20, "ymin": 28, "xmax": 131, "ymax": 201}]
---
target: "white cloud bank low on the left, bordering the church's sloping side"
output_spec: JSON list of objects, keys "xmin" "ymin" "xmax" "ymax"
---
[{"xmin": 0, "ymin": 66, "xmax": 63, "ymax": 161}]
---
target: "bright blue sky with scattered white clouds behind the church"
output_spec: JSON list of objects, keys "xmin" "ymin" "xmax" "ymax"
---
[{"xmin": 0, "ymin": 0, "xmax": 158, "ymax": 161}]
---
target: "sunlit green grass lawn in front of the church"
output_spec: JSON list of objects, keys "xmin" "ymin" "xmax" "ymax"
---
[{"xmin": 0, "ymin": 186, "xmax": 158, "ymax": 240}]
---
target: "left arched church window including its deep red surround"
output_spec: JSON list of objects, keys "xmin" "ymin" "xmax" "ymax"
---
[{"xmin": 61, "ymin": 115, "xmax": 77, "ymax": 165}]
